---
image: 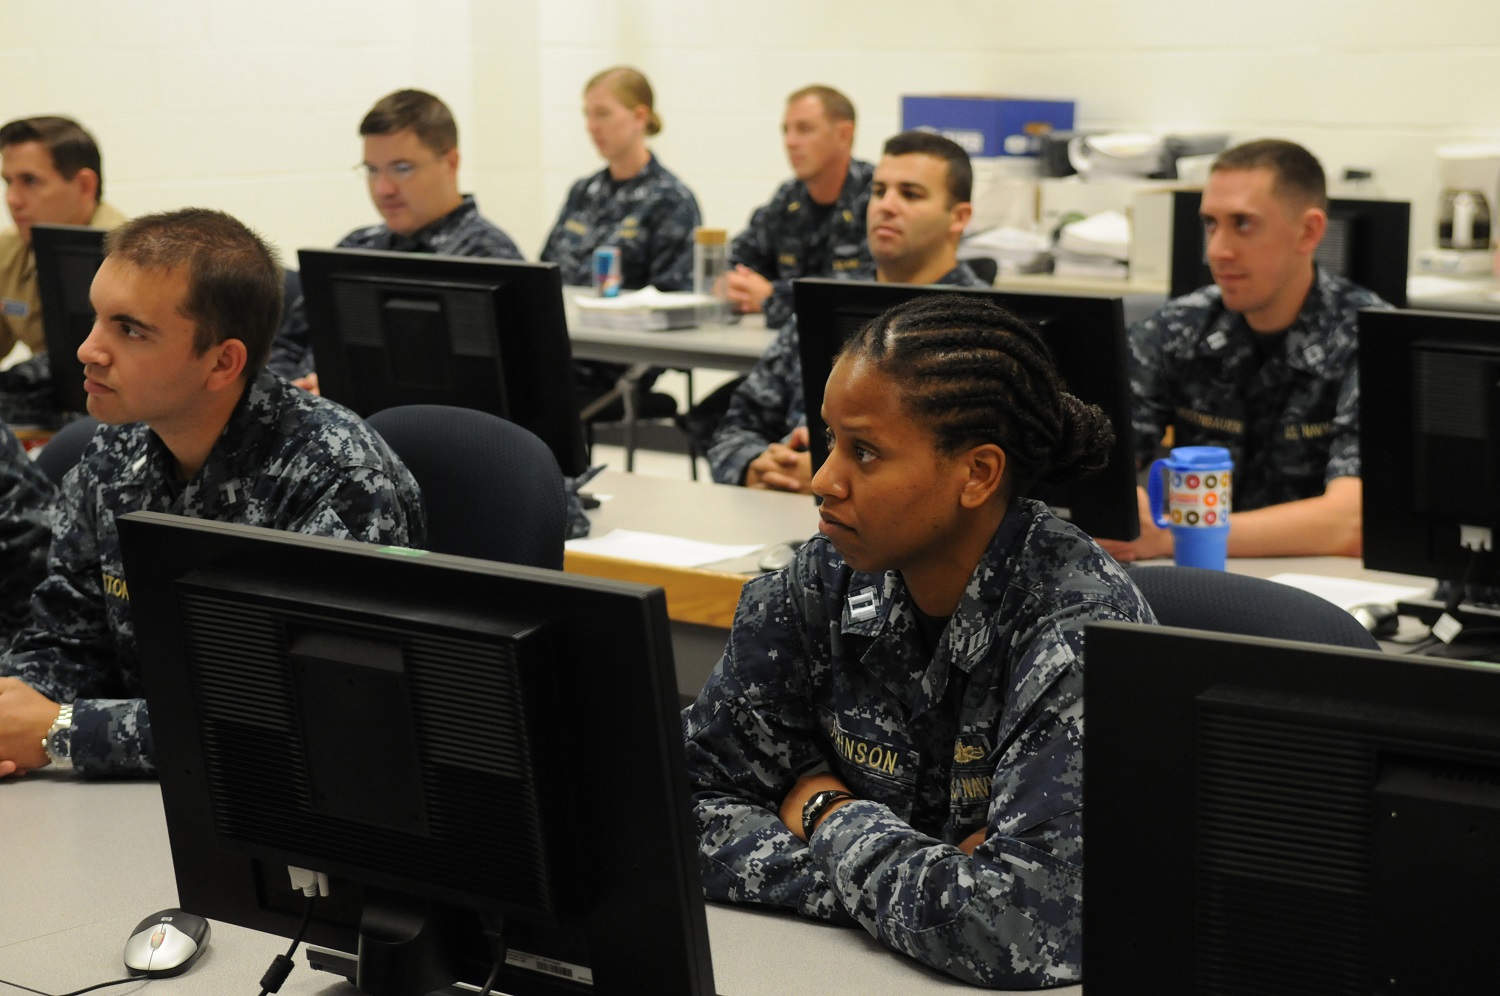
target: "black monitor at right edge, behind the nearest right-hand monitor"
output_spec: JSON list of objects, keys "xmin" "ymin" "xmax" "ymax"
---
[{"xmin": 1359, "ymin": 309, "xmax": 1500, "ymax": 626}]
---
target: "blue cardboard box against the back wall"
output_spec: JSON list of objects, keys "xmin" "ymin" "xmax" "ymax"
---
[{"xmin": 902, "ymin": 96, "xmax": 1073, "ymax": 158}]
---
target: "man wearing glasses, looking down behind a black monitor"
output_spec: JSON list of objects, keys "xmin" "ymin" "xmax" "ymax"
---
[{"xmin": 269, "ymin": 90, "xmax": 522, "ymax": 390}]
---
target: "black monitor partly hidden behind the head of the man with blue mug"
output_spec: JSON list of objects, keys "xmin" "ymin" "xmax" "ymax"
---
[{"xmin": 1167, "ymin": 191, "xmax": 1412, "ymax": 308}]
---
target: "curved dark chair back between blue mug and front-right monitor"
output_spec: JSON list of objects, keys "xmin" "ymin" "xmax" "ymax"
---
[{"xmin": 1130, "ymin": 566, "xmax": 1380, "ymax": 650}]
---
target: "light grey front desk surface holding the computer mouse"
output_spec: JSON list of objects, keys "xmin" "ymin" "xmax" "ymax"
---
[{"xmin": 0, "ymin": 770, "xmax": 1056, "ymax": 996}]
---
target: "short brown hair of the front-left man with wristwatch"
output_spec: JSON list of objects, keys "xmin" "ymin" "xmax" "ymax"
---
[{"xmin": 104, "ymin": 207, "xmax": 282, "ymax": 380}]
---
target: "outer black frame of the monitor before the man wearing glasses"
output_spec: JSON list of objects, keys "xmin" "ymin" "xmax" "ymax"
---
[{"xmin": 297, "ymin": 249, "xmax": 588, "ymax": 477}]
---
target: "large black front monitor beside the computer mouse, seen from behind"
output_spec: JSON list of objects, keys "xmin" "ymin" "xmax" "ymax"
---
[{"xmin": 120, "ymin": 513, "xmax": 714, "ymax": 996}]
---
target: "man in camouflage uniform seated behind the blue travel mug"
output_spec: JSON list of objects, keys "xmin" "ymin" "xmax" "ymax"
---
[{"xmin": 1104, "ymin": 140, "xmax": 1385, "ymax": 561}]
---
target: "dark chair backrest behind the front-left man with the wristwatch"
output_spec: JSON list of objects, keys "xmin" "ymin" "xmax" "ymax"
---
[{"xmin": 369, "ymin": 405, "xmax": 567, "ymax": 570}]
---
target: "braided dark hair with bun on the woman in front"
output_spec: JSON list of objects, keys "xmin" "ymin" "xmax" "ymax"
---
[{"xmin": 839, "ymin": 294, "xmax": 1115, "ymax": 495}]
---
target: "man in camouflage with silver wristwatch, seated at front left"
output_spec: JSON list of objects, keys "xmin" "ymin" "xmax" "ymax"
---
[{"xmin": 0, "ymin": 209, "xmax": 426, "ymax": 776}]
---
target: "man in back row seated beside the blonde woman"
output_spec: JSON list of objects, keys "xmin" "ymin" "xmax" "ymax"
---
[{"xmin": 725, "ymin": 86, "xmax": 875, "ymax": 329}]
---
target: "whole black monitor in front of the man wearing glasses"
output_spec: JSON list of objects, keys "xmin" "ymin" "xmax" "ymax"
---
[{"xmin": 297, "ymin": 249, "xmax": 588, "ymax": 477}]
